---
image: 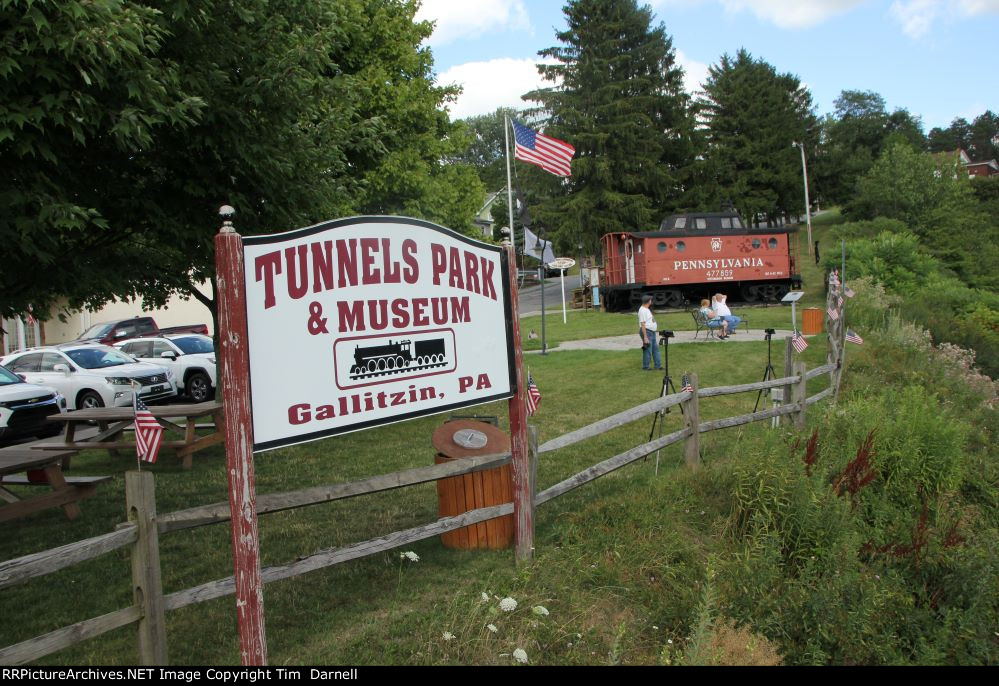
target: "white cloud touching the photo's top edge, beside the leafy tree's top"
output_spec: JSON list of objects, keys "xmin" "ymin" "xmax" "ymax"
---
[{"xmin": 416, "ymin": 0, "xmax": 530, "ymax": 46}]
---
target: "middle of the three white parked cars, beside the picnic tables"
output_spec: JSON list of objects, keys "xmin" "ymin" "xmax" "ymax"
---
[{"xmin": 0, "ymin": 343, "xmax": 177, "ymax": 410}]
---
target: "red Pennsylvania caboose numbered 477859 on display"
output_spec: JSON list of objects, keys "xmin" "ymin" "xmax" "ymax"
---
[{"xmin": 600, "ymin": 212, "xmax": 801, "ymax": 311}]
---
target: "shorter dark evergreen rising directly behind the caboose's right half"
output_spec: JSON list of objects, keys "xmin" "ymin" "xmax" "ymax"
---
[{"xmin": 698, "ymin": 50, "xmax": 817, "ymax": 226}]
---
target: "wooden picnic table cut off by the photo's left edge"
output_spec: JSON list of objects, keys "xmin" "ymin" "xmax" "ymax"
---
[{"xmin": 0, "ymin": 446, "xmax": 111, "ymax": 522}]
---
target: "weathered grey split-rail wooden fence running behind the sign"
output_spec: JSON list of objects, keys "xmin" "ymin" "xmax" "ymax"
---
[{"xmin": 0, "ymin": 345, "xmax": 840, "ymax": 664}]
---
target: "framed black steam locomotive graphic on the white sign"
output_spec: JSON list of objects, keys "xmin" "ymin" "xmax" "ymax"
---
[{"xmin": 333, "ymin": 329, "xmax": 456, "ymax": 388}]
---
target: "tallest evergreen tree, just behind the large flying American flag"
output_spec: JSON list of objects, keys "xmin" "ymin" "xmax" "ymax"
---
[{"xmin": 524, "ymin": 0, "xmax": 693, "ymax": 250}]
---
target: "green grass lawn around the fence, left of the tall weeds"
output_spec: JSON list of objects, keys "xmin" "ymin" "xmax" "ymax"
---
[{"xmin": 0, "ymin": 214, "xmax": 844, "ymax": 665}]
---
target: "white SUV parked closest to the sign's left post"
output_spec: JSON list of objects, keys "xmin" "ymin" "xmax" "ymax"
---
[{"xmin": 115, "ymin": 334, "xmax": 217, "ymax": 403}]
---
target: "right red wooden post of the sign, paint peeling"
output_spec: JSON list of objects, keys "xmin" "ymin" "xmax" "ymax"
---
[{"xmin": 507, "ymin": 247, "xmax": 543, "ymax": 563}]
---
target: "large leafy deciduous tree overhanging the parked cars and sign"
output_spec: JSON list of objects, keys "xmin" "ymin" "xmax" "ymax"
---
[{"xmin": 0, "ymin": 0, "xmax": 482, "ymax": 328}]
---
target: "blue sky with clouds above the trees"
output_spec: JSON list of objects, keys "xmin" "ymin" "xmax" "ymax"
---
[{"xmin": 417, "ymin": 0, "xmax": 999, "ymax": 133}]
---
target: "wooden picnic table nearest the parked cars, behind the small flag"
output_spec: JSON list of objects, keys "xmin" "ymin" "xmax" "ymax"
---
[{"xmin": 34, "ymin": 401, "xmax": 225, "ymax": 469}]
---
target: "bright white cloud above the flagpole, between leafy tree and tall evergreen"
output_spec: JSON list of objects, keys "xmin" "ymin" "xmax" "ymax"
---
[{"xmin": 437, "ymin": 57, "xmax": 551, "ymax": 119}]
